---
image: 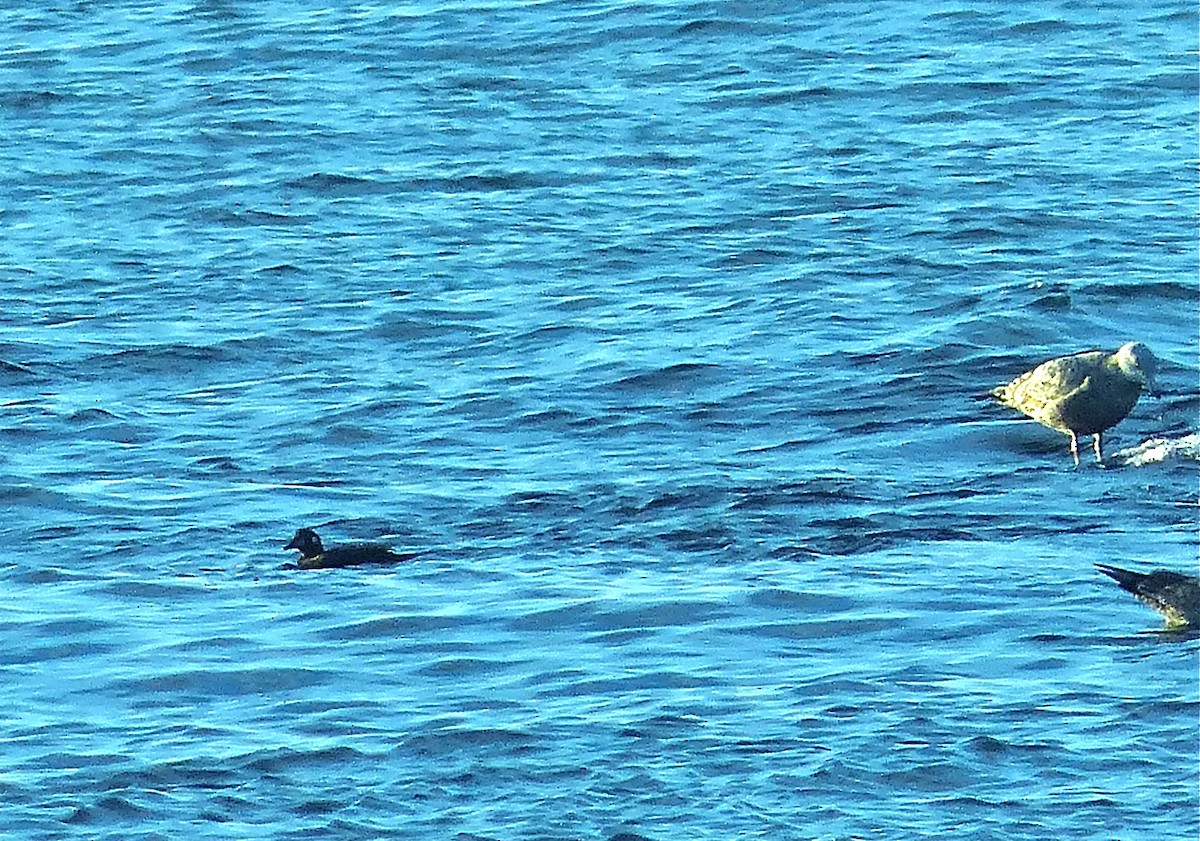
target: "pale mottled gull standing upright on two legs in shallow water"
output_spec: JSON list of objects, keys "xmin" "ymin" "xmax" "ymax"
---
[{"xmin": 991, "ymin": 342, "xmax": 1158, "ymax": 467}]
